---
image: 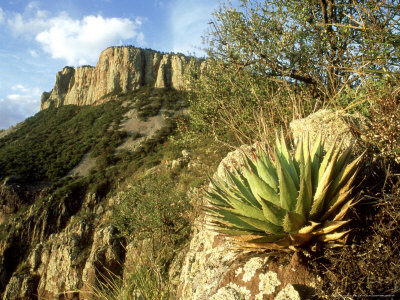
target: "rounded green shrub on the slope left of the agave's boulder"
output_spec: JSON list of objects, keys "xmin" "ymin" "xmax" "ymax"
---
[{"xmin": 113, "ymin": 173, "xmax": 189, "ymax": 243}]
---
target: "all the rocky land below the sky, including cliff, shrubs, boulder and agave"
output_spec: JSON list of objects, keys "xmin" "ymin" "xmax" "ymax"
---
[{"xmin": 0, "ymin": 28, "xmax": 400, "ymax": 300}]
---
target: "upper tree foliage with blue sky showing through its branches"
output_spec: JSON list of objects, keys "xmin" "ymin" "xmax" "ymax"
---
[{"xmin": 207, "ymin": 0, "xmax": 400, "ymax": 98}]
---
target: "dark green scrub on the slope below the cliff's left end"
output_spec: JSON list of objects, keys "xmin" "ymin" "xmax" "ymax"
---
[{"xmin": 0, "ymin": 101, "xmax": 126, "ymax": 182}]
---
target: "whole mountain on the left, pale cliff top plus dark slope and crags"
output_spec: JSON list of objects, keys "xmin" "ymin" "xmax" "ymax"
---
[{"xmin": 0, "ymin": 47, "xmax": 206, "ymax": 299}]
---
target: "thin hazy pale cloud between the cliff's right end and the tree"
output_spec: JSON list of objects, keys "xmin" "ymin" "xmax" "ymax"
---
[{"xmin": 170, "ymin": 0, "xmax": 218, "ymax": 54}]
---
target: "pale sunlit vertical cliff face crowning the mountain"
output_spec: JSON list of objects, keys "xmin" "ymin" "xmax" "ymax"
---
[{"xmin": 41, "ymin": 47, "xmax": 200, "ymax": 110}]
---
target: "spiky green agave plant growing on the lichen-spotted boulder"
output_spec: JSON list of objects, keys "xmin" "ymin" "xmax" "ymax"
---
[{"xmin": 205, "ymin": 134, "xmax": 362, "ymax": 250}]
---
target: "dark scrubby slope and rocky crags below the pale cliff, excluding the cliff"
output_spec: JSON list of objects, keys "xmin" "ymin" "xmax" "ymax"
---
[{"xmin": 0, "ymin": 89, "xmax": 198, "ymax": 299}]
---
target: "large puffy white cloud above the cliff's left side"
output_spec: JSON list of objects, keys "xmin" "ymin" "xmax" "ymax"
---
[{"xmin": 8, "ymin": 2, "xmax": 145, "ymax": 65}]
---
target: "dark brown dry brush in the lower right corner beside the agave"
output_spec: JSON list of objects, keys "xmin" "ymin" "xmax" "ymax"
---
[{"xmin": 313, "ymin": 169, "xmax": 400, "ymax": 299}]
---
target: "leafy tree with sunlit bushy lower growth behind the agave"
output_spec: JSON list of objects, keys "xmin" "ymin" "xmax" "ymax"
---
[{"xmin": 192, "ymin": 0, "xmax": 400, "ymax": 143}]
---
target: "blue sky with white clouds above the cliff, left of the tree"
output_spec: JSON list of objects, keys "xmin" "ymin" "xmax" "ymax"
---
[{"xmin": 0, "ymin": 0, "xmax": 218, "ymax": 129}]
